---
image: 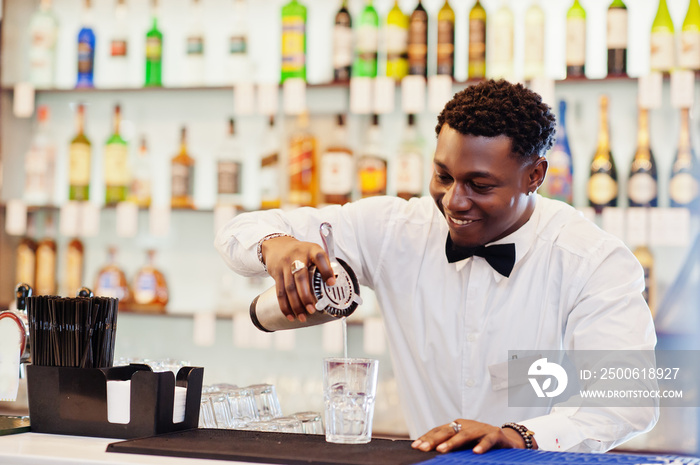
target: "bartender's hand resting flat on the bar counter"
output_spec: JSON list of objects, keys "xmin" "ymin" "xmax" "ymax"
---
[{"xmin": 411, "ymin": 419, "xmax": 537, "ymax": 454}]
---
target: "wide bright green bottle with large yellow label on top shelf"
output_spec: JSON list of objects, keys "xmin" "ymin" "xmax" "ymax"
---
[{"xmin": 281, "ymin": 0, "xmax": 306, "ymax": 82}]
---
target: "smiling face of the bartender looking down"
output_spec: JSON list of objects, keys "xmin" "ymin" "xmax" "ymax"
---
[{"xmin": 430, "ymin": 124, "xmax": 547, "ymax": 247}]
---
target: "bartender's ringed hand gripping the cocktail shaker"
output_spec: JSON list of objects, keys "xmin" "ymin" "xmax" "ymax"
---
[{"xmin": 261, "ymin": 236, "xmax": 335, "ymax": 322}]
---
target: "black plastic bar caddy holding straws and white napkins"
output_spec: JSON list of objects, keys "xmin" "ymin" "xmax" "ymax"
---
[{"xmin": 27, "ymin": 364, "xmax": 204, "ymax": 439}]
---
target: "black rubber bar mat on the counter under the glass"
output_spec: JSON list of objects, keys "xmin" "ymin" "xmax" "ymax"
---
[{"xmin": 107, "ymin": 429, "xmax": 437, "ymax": 465}]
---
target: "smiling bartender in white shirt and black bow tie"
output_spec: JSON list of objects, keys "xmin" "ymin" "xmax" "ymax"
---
[{"xmin": 216, "ymin": 80, "xmax": 658, "ymax": 453}]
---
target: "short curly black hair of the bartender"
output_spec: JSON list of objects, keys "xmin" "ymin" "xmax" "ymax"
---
[{"xmin": 435, "ymin": 79, "xmax": 556, "ymax": 158}]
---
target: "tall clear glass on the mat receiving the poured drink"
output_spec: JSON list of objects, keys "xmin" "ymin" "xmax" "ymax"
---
[{"xmin": 323, "ymin": 358, "xmax": 379, "ymax": 444}]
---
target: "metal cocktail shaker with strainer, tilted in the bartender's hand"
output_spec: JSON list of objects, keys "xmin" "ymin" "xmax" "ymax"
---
[{"xmin": 250, "ymin": 223, "xmax": 362, "ymax": 332}]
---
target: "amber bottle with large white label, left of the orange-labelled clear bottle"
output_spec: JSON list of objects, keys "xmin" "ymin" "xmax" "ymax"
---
[{"xmin": 319, "ymin": 115, "xmax": 355, "ymax": 205}]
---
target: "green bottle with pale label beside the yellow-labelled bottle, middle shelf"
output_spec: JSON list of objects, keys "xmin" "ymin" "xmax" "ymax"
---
[{"xmin": 104, "ymin": 105, "xmax": 129, "ymax": 205}]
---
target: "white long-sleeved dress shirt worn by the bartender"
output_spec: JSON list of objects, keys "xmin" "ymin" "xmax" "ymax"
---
[{"xmin": 215, "ymin": 196, "xmax": 658, "ymax": 451}]
